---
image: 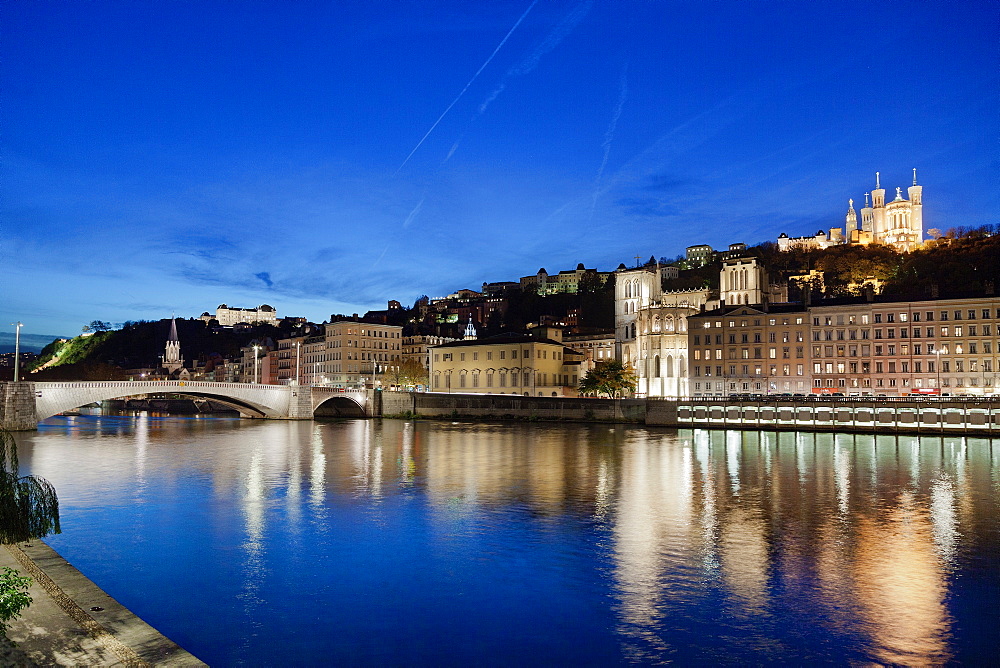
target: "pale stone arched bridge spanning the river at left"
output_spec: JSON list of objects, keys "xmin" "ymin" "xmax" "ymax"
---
[{"xmin": 0, "ymin": 380, "xmax": 378, "ymax": 430}]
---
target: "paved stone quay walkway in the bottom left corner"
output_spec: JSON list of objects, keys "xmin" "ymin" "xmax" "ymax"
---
[{"xmin": 0, "ymin": 540, "xmax": 205, "ymax": 667}]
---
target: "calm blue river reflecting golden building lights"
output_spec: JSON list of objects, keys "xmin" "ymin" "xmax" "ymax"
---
[{"xmin": 9, "ymin": 416, "xmax": 1000, "ymax": 666}]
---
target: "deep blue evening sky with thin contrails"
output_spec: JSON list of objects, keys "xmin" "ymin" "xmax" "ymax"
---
[{"xmin": 0, "ymin": 0, "xmax": 1000, "ymax": 335}]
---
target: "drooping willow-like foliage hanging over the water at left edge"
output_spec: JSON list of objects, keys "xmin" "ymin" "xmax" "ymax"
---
[{"xmin": 0, "ymin": 430, "xmax": 61, "ymax": 544}]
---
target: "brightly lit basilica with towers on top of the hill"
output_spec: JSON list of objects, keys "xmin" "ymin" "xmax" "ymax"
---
[{"xmin": 778, "ymin": 169, "xmax": 924, "ymax": 251}]
